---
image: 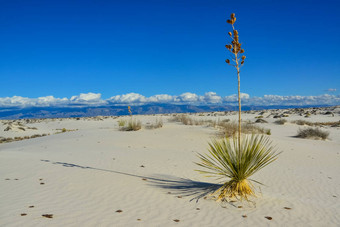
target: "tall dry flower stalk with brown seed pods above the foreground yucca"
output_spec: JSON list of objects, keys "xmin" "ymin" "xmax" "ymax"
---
[{"xmin": 225, "ymin": 13, "xmax": 246, "ymax": 146}]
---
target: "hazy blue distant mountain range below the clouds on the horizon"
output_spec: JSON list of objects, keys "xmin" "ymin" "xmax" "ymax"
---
[{"xmin": 0, "ymin": 104, "xmax": 332, "ymax": 119}]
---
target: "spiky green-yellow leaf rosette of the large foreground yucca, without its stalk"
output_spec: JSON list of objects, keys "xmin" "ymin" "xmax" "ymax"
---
[{"xmin": 196, "ymin": 134, "xmax": 279, "ymax": 201}]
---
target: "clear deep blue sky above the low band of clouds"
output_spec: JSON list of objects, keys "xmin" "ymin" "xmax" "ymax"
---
[{"xmin": 0, "ymin": 0, "xmax": 340, "ymax": 104}]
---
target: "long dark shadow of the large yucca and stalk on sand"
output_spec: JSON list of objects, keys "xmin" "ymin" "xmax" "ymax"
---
[{"xmin": 41, "ymin": 160, "xmax": 222, "ymax": 202}]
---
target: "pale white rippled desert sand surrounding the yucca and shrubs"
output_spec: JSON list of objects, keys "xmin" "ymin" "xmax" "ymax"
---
[{"xmin": 0, "ymin": 107, "xmax": 340, "ymax": 226}]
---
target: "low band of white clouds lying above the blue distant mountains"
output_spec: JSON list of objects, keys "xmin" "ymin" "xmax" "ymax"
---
[{"xmin": 0, "ymin": 92, "xmax": 340, "ymax": 108}]
